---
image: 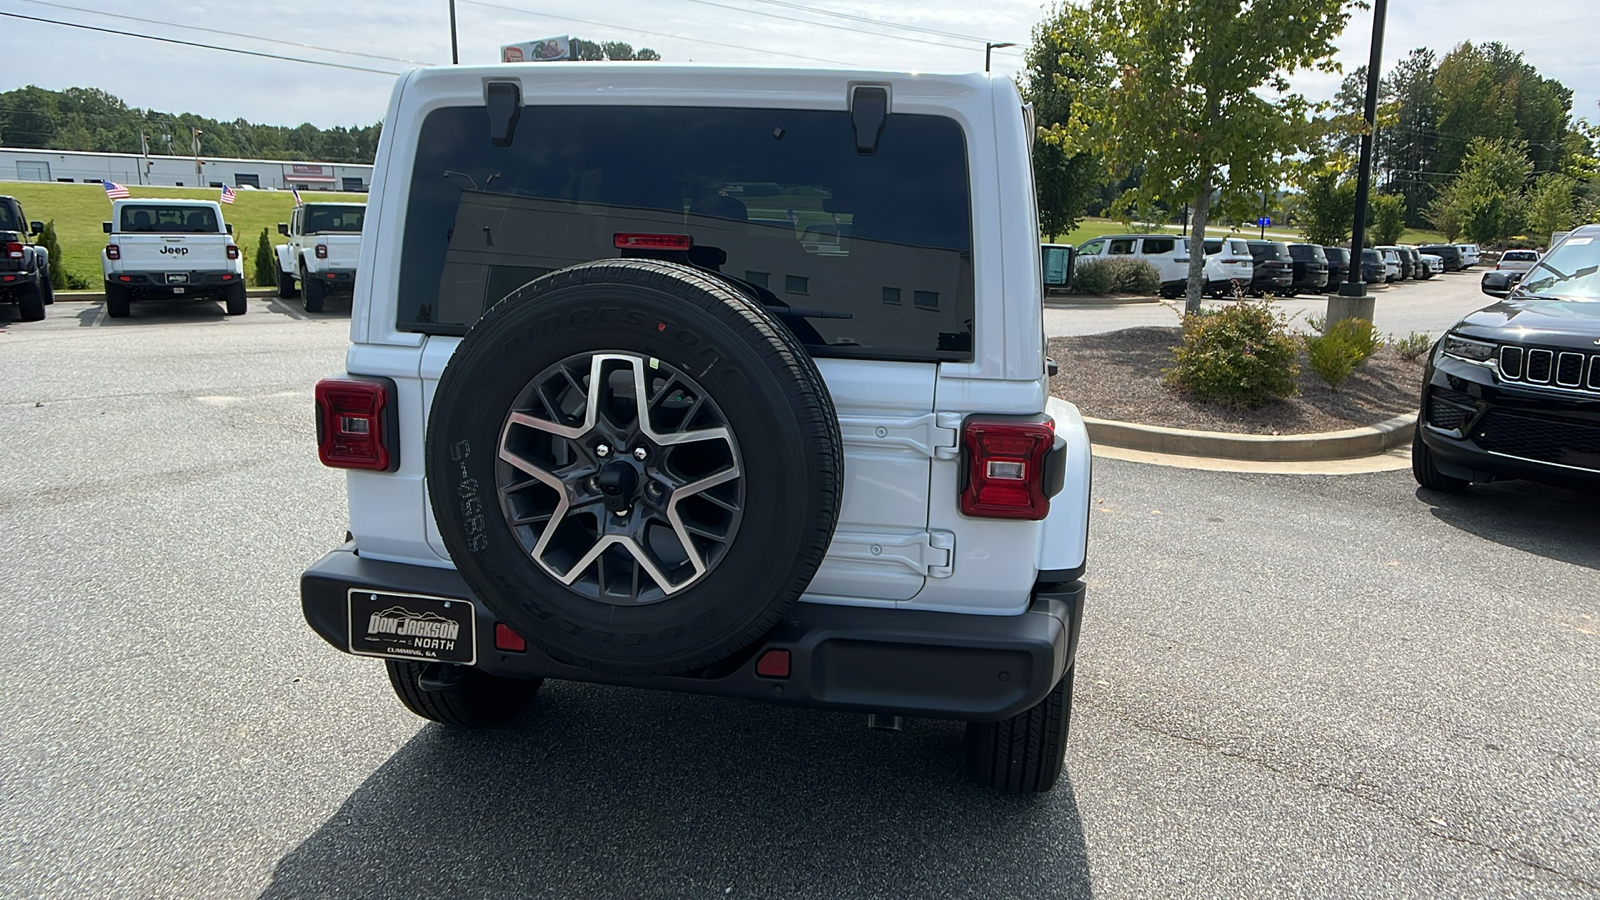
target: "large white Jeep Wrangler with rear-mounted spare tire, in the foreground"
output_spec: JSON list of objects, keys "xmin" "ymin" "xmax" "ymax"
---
[{"xmin": 301, "ymin": 64, "xmax": 1090, "ymax": 791}]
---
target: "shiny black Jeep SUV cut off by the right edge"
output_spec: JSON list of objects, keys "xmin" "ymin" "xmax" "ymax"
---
[{"xmin": 1411, "ymin": 226, "xmax": 1600, "ymax": 492}]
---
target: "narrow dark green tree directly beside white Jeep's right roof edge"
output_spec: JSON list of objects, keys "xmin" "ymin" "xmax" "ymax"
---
[{"xmin": 1019, "ymin": 6, "xmax": 1101, "ymax": 240}]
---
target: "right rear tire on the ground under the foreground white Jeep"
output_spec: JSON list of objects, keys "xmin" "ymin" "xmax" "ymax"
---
[{"xmin": 966, "ymin": 668, "xmax": 1077, "ymax": 794}]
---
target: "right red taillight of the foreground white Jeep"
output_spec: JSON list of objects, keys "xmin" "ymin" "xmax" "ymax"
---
[{"xmin": 960, "ymin": 418, "xmax": 1056, "ymax": 519}]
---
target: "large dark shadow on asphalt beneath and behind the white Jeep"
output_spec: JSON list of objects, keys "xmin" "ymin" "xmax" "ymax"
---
[{"xmin": 262, "ymin": 679, "xmax": 1091, "ymax": 898}]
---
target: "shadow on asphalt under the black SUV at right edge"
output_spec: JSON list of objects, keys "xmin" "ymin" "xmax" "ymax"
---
[{"xmin": 1416, "ymin": 480, "xmax": 1600, "ymax": 569}]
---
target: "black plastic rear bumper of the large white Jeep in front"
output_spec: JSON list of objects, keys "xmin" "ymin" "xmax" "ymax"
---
[{"xmin": 301, "ymin": 544, "xmax": 1085, "ymax": 721}]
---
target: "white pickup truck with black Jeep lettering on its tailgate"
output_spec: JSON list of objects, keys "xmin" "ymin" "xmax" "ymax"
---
[{"xmin": 101, "ymin": 200, "xmax": 246, "ymax": 319}]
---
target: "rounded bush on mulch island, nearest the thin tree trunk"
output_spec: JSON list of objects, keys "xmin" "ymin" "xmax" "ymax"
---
[{"xmin": 1162, "ymin": 301, "xmax": 1299, "ymax": 407}]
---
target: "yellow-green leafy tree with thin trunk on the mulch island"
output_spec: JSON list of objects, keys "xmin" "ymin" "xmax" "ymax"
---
[{"xmin": 1077, "ymin": 0, "xmax": 1349, "ymax": 312}]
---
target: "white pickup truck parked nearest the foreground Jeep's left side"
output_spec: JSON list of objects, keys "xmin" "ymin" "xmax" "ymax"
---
[{"xmin": 274, "ymin": 203, "xmax": 366, "ymax": 312}]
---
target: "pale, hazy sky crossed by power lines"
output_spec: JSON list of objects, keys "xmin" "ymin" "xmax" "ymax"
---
[{"xmin": 0, "ymin": 0, "xmax": 1600, "ymax": 128}]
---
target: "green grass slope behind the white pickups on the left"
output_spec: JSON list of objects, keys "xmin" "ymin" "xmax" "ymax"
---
[{"xmin": 0, "ymin": 181, "xmax": 366, "ymax": 283}]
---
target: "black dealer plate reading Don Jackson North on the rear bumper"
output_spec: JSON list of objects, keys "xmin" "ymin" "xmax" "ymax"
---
[{"xmin": 349, "ymin": 588, "xmax": 478, "ymax": 666}]
